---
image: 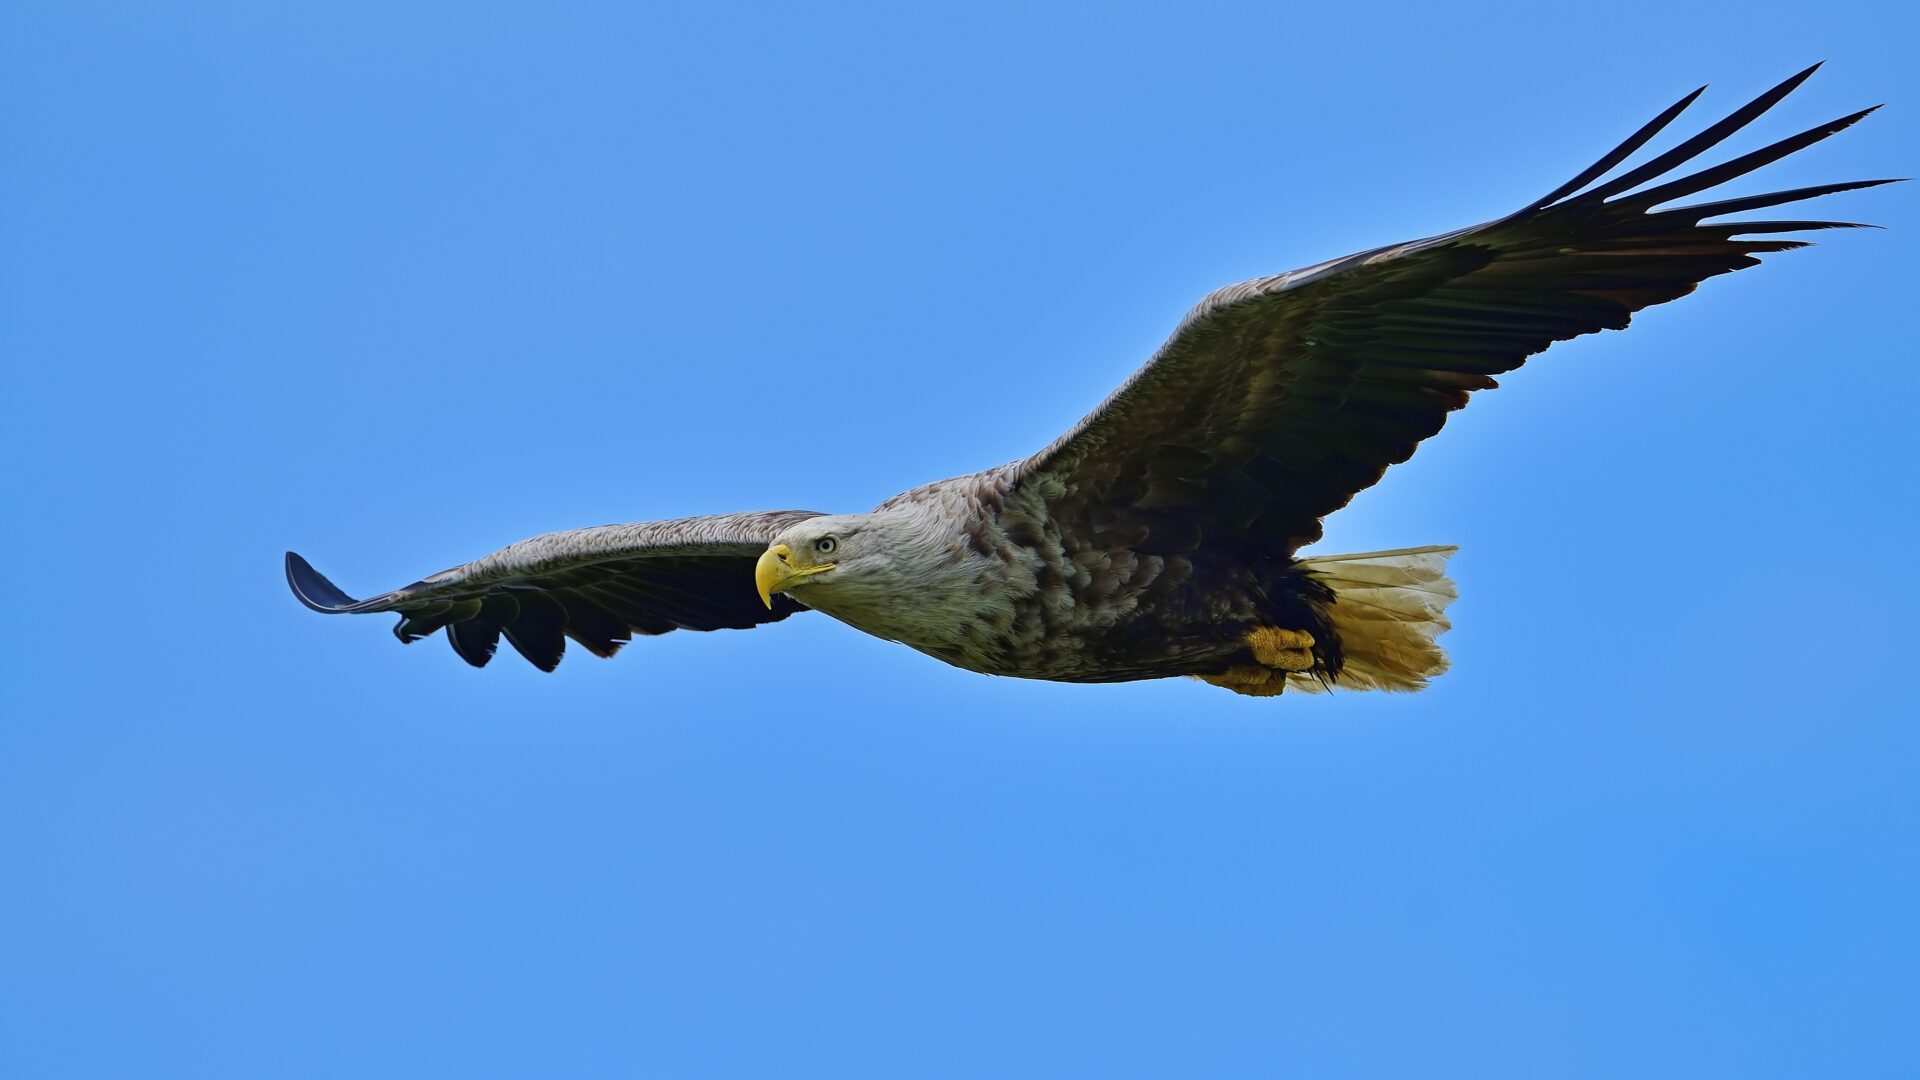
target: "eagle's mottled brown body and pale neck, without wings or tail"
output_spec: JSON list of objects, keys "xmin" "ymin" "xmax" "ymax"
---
[{"xmin": 825, "ymin": 467, "xmax": 1325, "ymax": 682}]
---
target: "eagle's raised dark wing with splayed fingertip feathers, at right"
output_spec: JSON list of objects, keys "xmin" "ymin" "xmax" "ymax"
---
[{"xmin": 1002, "ymin": 65, "xmax": 1893, "ymax": 553}]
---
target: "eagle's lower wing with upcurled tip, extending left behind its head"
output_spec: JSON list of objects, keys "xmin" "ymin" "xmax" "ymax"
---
[{"xmin": 286, "ymin": 509, "xmax": 820, "ymax": 671}]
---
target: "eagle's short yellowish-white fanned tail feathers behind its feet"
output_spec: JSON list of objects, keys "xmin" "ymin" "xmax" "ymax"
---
[{"xmin": 1286, "ymin": 548, "xmax": 1459, "ymax": 694}]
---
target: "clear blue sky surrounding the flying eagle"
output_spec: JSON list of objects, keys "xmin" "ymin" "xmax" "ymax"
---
[{"xmin": 0, "ymin": 2, "xmax": 1920, "ymax": 1080}]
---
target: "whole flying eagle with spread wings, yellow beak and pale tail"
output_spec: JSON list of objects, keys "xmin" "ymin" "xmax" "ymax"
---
[{"xmin": 286, "ymin": 65, "xmax": 1895, "ymax": 696}]
